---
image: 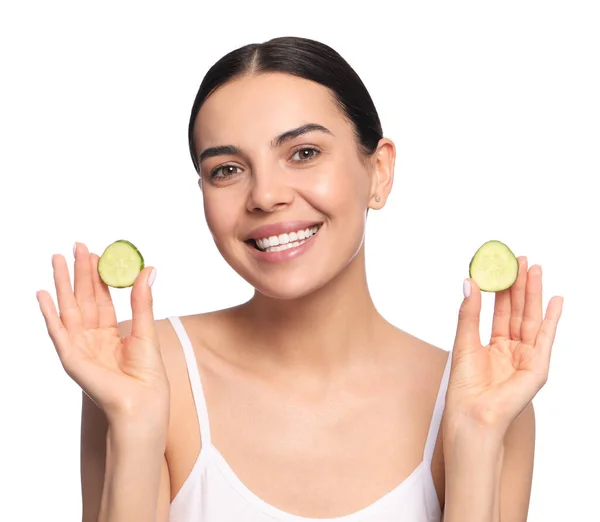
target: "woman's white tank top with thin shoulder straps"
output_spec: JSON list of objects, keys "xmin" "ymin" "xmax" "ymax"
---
[{"xmin": 169, "ymin": 317, "xmax": 451, "ymax": 522}]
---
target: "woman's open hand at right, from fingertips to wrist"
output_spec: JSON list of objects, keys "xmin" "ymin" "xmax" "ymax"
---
[{"xmin": 445, "ymin": 257, "xmax": 563, "ymax": 434}]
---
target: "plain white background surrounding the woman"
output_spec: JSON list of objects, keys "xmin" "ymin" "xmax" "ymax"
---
[{"xmin": 0, "ymin": 0, "xmax": 600, "ymax": 522}]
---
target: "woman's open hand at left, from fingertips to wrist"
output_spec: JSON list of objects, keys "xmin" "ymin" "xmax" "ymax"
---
[{"xmin": 37, "ymin": 243, "xmax": 169, "ymax": 435}]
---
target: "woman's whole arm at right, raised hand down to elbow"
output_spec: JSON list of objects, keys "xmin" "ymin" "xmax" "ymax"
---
[{"xmin": 443, "ymin": 257, "xmax": 563, "ymax": 522}]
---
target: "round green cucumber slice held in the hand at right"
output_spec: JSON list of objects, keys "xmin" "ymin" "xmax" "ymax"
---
[{"xmin": 469, "ymin": 240, "xmax": 519, "ymax": 292}]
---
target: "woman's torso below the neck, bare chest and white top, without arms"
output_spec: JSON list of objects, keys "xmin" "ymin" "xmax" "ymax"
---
[{"xmin": 159, "ymin": 312, "xmax": 448, "ymax": 522}]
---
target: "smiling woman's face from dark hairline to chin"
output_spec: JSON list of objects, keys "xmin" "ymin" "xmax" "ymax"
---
[{"xmin": 194, "ymin": 73, "xmax": 393, "ymax": 299}]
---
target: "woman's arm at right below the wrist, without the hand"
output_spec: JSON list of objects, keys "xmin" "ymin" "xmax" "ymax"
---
[{"xmin": 443, "ymin": 404, "xmax": 535, "ymax": 522}]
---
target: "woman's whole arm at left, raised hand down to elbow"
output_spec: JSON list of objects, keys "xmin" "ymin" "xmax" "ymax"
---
[{"xmin": 36, "ymin": 247, "xmax": 170, "ymax": 522}]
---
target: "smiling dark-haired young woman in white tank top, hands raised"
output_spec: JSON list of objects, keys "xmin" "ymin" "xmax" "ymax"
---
[{"xmin": 38, "ymin": 38, "xmax": 562, "ymax": 522}]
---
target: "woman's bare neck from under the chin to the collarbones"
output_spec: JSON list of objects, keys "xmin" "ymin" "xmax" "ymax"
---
[{"xmin": 238, "ymin": 249, "xmax": 385, "ymax": 374}]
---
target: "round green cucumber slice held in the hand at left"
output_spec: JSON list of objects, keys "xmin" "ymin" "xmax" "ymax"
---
[{"xmin": 98, "ymin": 239, "xmax": 144, "ymax": 288}]
